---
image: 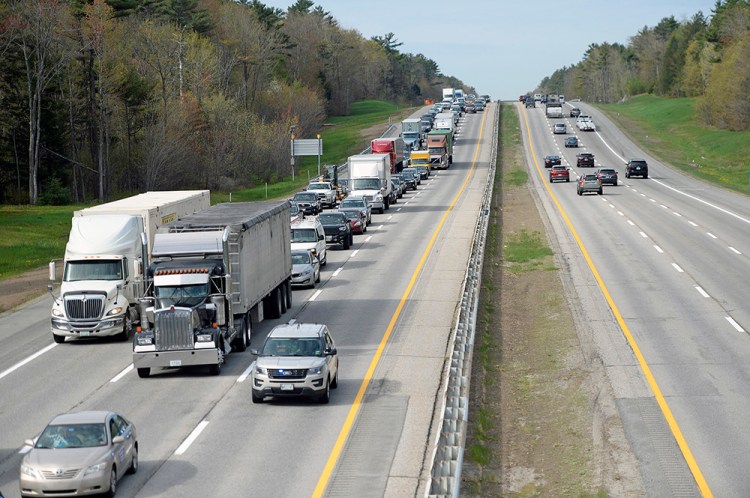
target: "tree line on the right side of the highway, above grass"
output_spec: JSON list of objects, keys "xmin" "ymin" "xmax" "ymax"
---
[{"xmin": 539, "ymin": 0, "xmax": 750, "ymax": 130}]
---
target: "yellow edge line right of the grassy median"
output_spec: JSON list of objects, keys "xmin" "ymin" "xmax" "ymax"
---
[{"xmin": 521, "ymin": 107, "xmax": 713, "ymax": 497}]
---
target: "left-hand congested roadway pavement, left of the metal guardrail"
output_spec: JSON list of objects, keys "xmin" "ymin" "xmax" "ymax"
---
[{"xmin": 0, "ymin": 104, "xmax": 496, "ymax": 497}]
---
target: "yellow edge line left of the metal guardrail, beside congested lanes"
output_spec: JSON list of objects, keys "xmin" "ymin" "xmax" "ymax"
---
[{"xmin": 312, "ymin": 106, "xmax": 499, "ymax": 498}]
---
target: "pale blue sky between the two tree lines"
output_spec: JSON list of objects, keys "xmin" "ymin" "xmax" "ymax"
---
[{"xmin": 261, "ymin": 0, "xmax": 716, "ymax": 100}]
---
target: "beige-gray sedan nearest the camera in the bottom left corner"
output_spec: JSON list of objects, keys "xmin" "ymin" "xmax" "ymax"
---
[{"xmin": 19, "ymin": 411, "xmax": 138, "ymax": 496}]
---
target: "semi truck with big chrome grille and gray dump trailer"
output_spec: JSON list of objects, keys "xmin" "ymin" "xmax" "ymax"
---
[{"xmin": 133, "ymin": 201, "xmax": 292, "ymax": 378}]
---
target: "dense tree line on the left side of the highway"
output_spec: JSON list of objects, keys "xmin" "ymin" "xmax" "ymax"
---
[{"xmin": 0, "ymin": 0, "xmax": 467, "ymax": 204}]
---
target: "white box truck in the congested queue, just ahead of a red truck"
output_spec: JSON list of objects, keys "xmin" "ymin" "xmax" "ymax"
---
[{"xmin": 347, "ymin": 154, "xmax": 392, "ymax": 214}]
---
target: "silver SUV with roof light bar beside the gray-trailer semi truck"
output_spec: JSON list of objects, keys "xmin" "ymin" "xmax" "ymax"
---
[{"xmin": 250, "ymin": 323, "xmax": 339, "ymax": 403}]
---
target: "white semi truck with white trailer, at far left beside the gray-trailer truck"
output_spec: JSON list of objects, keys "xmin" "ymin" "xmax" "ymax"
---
[{"xmin": 48, "ymin": 190, "xmax": 211, "ymax": 343}]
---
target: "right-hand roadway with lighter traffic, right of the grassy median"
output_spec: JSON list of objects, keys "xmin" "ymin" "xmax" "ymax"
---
[{"xmin": 516, "ymin": 102, "xmax": 750, "ymax": 496}]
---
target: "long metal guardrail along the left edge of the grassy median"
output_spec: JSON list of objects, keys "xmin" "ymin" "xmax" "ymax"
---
[{"xmin": 425, "ymin": 104, "xmax": 500, "ymax": 498}]
